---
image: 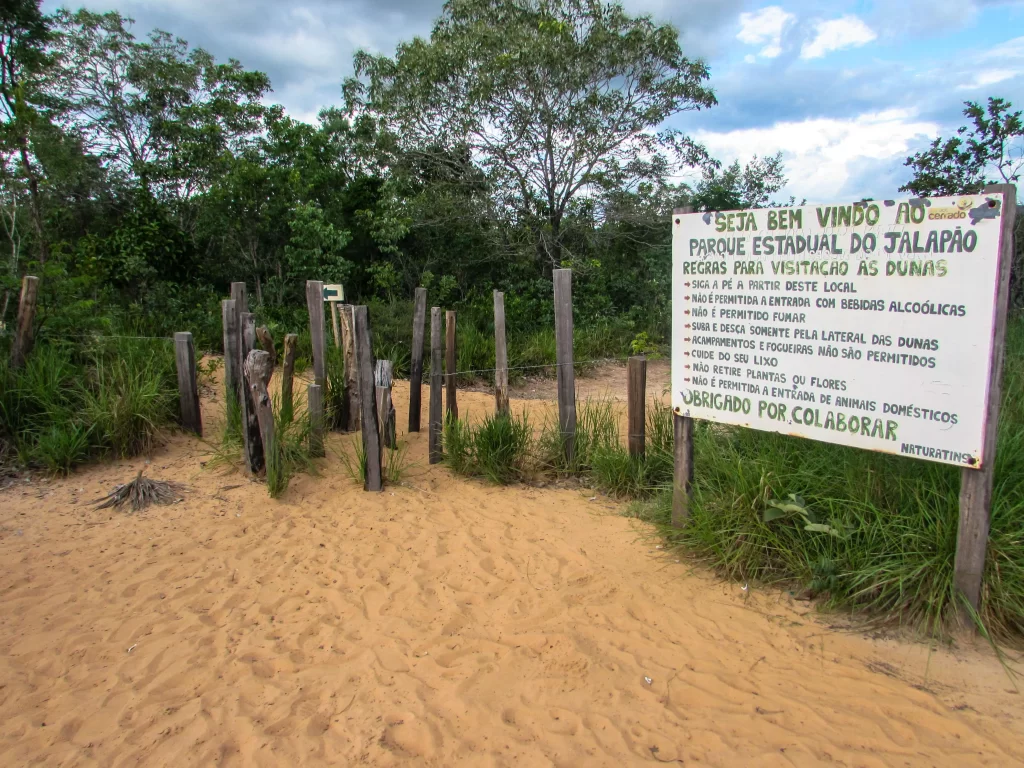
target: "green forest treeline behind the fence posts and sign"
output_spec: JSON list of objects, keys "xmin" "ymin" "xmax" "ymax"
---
[{"xmin": 0, "ymin": 0, "xmax": 1020, "ymax": 353}]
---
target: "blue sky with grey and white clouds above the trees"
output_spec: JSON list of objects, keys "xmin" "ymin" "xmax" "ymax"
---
[{"xmin": 43, "ymin": 0, "xmax": 1024, "ymax": 202}]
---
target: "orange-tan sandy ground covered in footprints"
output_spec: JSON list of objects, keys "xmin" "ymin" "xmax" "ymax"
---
[{"xmin": 0, "ymin": 369, "xmax": 1024, "ymax": 766}]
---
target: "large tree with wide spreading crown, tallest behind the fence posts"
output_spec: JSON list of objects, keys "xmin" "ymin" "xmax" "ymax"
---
[{"xmin": 344, "ymin": 0, "xmax": 716, "ymax": 268}]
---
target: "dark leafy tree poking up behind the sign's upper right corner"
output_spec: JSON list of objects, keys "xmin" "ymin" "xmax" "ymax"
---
[{"xmin": 900, "ymin": 98, "xmax": 1024, "ymax": 197}]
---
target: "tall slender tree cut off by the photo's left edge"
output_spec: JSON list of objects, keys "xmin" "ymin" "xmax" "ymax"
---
[{"xmin": 0, "ymin": 0, "xmax": 50, "ymax": 264}]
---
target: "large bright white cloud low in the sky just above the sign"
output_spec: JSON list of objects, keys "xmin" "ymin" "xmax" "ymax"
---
[{"xmin": 693, "ymin": 110, "xmax": 939, "ymax": 203}]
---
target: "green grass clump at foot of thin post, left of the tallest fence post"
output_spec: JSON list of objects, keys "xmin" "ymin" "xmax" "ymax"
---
[{"xmin": 444, "ymin": 414, "xmax": 534, "ymax": 485}]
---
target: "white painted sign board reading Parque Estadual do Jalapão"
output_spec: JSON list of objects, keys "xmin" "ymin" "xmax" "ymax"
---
[{"xmin": 672, "ymin": 195, "xmax": 1001, "ymax": 468}]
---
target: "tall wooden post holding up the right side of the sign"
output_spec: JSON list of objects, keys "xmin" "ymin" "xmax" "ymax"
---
[{"xmin": 953, "ymin": 184, "xmax": 1017, "ymax": 627}]
